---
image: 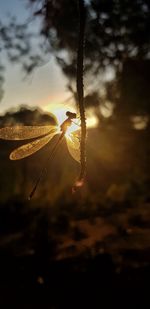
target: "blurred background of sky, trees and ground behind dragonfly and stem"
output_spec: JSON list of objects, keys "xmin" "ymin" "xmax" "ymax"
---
[{"xmin": 0, "ymin": 0, "xmax": 150, "ymax": 308}]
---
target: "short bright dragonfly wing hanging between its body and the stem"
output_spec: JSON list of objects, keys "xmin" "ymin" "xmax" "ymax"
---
[{"xmin": 66, "ymin": 130, "xmax": 80, "ymax": 162}]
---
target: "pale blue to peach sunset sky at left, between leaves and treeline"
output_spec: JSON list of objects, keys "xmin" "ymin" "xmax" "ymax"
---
[{"xmin": 0, "ymin": 0, "xmax": 69, "ymax": 113}]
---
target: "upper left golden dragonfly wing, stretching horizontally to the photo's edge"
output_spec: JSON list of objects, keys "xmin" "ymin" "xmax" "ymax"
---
[{"xmin": 0, "ymin": 126, "xmax": 56, "ymax": 140}]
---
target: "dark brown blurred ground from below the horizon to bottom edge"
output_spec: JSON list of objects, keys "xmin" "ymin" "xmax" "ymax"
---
[{"xmin": 0, "ymin": 109, "xmax": 150, "ymax": 309}]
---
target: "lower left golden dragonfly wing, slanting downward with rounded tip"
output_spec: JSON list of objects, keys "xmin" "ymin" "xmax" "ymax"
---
[{"xmin": 9, "ymin": 130, "xmax": 58, "ymax": 160}]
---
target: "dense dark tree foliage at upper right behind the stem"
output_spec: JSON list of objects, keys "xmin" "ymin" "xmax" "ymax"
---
[{"xmin": 26, "ymin": 0, "xmax": 150, "ymax": 78}]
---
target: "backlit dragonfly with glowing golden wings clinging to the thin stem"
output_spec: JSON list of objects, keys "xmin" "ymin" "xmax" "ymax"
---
[{"xmin": 0, "ymin": 111, "xmax": 80, "ymax": 199}]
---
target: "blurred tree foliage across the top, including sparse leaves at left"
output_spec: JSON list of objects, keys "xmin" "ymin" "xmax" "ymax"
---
[{"xmin": 0, "ymin": 0, "xmax": 150, "ymax": 110}]
